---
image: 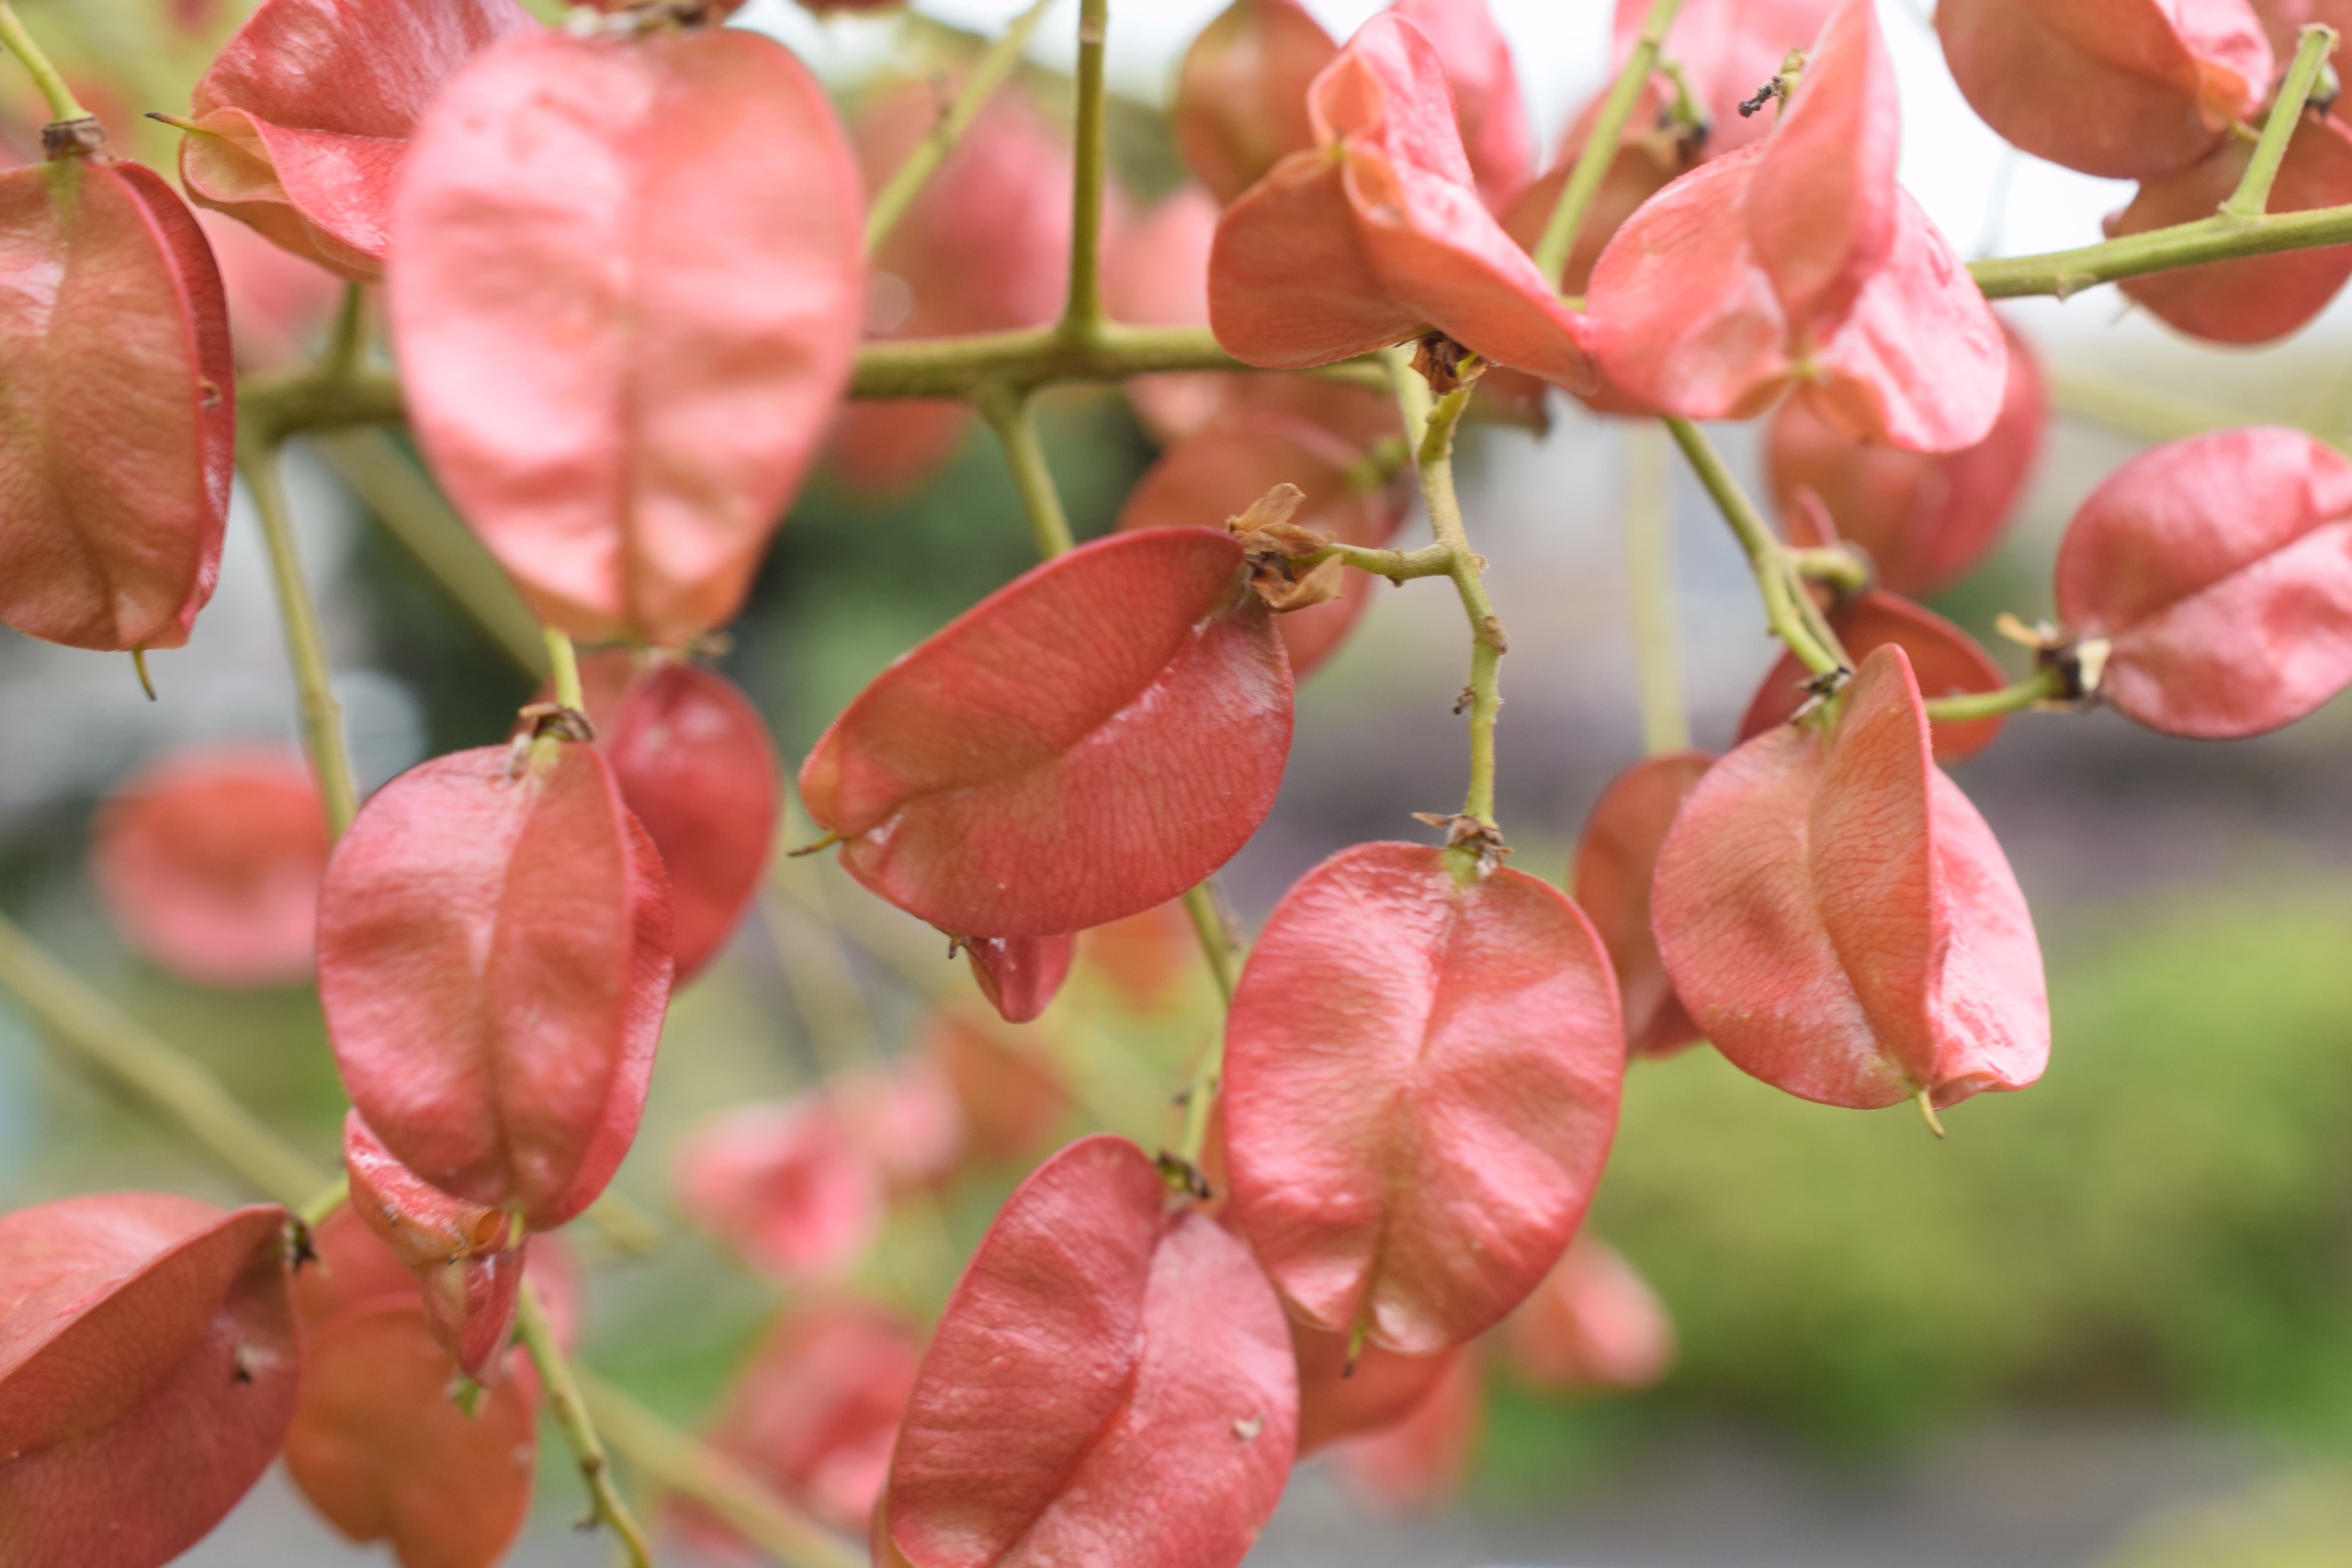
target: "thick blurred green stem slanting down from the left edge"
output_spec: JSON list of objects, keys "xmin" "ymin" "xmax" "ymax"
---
[{"xmin": 0, "ymin": 917, "xmax": 329, "ymax": 1208}]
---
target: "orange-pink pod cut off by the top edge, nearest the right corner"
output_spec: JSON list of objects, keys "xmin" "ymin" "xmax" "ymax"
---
[{"xmin": 1928, "ymin": 0, "xmax": 2275, "ymax": 179}]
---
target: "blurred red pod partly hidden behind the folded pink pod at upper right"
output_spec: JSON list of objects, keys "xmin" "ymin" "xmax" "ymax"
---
[{"xmin": 1764, "ymin": 322, "xmax": 2049, "ymax": 597}]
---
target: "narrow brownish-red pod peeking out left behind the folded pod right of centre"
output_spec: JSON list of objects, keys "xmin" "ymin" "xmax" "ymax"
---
[{"xmin": 1574, "ymin": 752, "xmax": 1714, "ymax": 1055}]
